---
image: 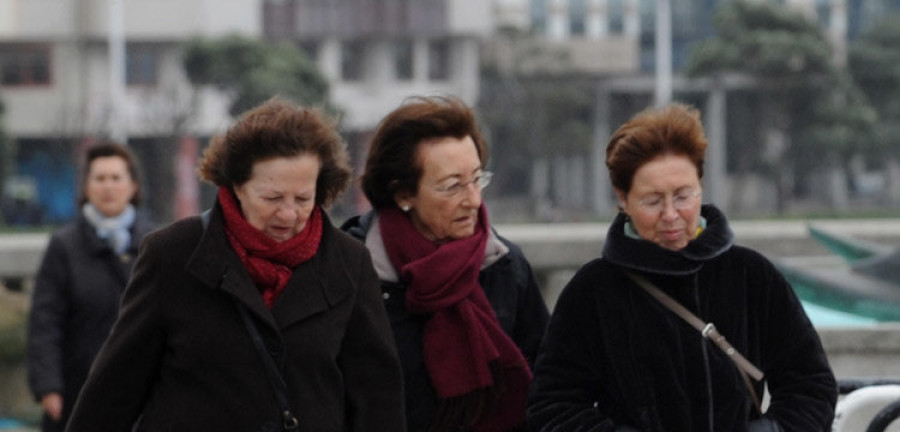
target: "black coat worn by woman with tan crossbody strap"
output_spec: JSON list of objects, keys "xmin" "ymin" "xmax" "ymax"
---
[{"xmin": 528, "ymin": 206, "xmax": 837, "ymax": 432}]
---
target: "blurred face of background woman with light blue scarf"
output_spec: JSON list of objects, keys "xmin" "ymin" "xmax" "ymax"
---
[{"xmin": 84, "ymin": 156, "xmax": 138, "ymax": 217}]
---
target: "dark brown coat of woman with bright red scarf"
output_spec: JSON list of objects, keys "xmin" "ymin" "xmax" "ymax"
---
[{"xmin": 60, "ymin": 205, "xmax": 405, "ymax": 432}]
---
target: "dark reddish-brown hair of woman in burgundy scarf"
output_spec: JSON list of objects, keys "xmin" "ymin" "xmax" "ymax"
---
[{"xmin": 362, "ymin": 96, "xmax": 488, "ymax": 209}]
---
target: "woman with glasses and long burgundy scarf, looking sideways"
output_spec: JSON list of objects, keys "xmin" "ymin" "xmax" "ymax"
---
[{"xmin": 344, "ymin": 97, "xmax": 548, "ymax": 431}]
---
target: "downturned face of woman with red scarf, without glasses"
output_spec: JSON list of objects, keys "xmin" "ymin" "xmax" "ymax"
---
[{"xmin": 234, "ymin": 153, "xmax": 320, "ymax": 243}]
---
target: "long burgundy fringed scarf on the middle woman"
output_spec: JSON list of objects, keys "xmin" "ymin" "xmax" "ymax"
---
[{"xmin": 378, "ymin": 205, "xmax": 532, "ymax": 431}]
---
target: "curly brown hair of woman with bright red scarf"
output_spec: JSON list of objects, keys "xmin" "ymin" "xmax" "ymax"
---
[{"xmin": 199, "ymin": 98, "xmax": 351, "ymax": 206}]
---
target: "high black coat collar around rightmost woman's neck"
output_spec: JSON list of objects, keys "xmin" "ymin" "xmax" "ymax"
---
[{"xmin": 603, "ymin": 204, "xmax": 734, "ymax": 275}]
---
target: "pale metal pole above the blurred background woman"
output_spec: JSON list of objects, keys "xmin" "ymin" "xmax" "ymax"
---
[{"xmin": 108, "ymin": 0, "xmax": 128, "ymax": 145}]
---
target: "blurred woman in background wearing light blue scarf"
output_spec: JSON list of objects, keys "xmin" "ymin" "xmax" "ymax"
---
[{"xmin": 27, "ymin": 142, "xmax": 151, "ymax": 431}]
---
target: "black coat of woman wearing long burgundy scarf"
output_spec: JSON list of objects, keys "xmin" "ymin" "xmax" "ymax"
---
[{"xmin": 342, "ymin": 212, "xmax": 549, "ymax": 432}]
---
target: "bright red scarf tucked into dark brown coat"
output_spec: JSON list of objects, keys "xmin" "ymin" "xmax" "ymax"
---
[{"xmin": 219, "ymin": 187, "xmax": 322, "ymax": 308}]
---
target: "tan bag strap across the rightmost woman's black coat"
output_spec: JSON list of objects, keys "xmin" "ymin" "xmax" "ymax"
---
[{"xmin": 625, "ymin": 271, "xmax": 763, "ymax": 413}]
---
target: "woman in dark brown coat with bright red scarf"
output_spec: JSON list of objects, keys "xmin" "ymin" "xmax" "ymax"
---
[{"xmin": 67, "ymin": 99, "xmax": 405, "ymax": 432}]
